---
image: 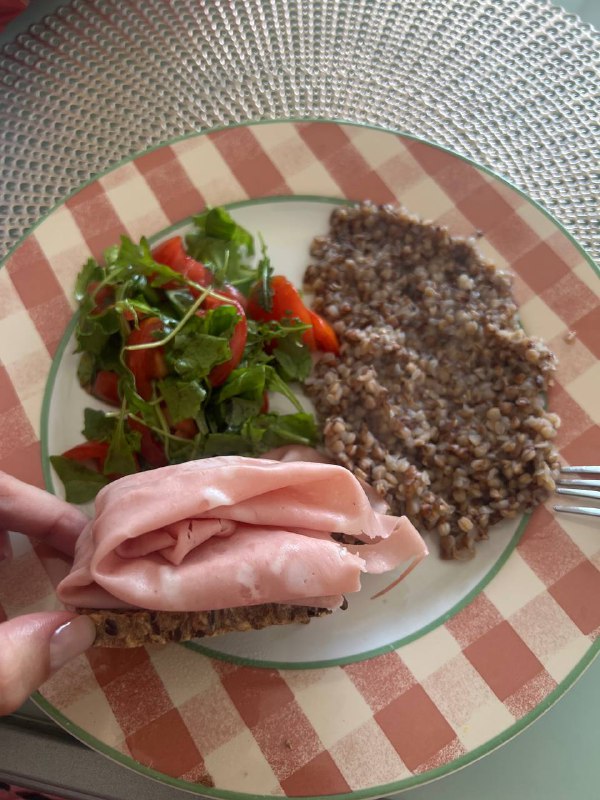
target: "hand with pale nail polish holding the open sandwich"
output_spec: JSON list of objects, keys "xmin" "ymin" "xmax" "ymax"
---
[{"xmin": 0, "ymin": 472, "xmax": 95, "ymax": 715}]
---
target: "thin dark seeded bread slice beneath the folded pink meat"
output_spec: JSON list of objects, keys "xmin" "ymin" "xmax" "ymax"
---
[{"xmin": 77, "ymin": 603, "xmax": 331, "ymax": 647}]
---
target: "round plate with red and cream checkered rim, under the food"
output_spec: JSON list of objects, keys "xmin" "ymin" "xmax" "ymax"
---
[{"xmin": 0, "ymin": 122, "xmax": 600, "ymax": 798}]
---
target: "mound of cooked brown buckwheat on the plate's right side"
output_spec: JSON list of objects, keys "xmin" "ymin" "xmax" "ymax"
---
[{"xmin": 305, "ymin": 203, "xmax": 560, "ymax": 558}]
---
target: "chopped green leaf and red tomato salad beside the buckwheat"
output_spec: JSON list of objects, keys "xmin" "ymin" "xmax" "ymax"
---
[{"xmin": 50, "ymin": 208, "xmax": 337, "ymax": 503}]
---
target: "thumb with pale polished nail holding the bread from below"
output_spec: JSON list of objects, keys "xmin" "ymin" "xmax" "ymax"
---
[{"xmin": 0, "ymin": 611, "xmax": 96, "ymax": 715}]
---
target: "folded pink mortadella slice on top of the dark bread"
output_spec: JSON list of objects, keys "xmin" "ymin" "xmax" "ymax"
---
[{"xmin": 57, "ymin": 453, "xmax": 427, "ymax": 611}]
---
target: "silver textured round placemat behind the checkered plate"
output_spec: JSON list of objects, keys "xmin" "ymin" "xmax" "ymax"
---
[{"xmin": 0, "ymin": 0, "xmax": 600, "ymax": 257}]
